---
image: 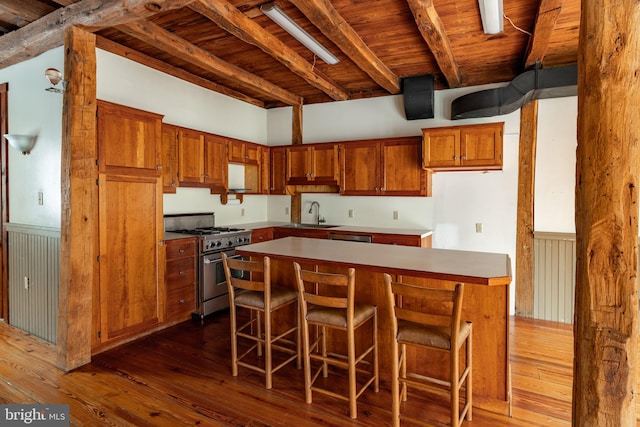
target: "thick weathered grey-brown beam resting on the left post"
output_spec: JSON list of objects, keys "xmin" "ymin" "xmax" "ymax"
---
[{"xmin": 0, "ymin": 0, "xmax": 198, "ymax": 69}]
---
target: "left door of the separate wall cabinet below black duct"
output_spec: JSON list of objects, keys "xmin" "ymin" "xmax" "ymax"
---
[{"xmin": 422, "ymin": 128, "xmax": 460, "ymax": 169}]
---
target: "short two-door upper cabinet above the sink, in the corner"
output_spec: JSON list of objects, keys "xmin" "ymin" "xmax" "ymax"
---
[{"xmin": 286, "ymin": 143, "xmax": 340, "ymax": 185}]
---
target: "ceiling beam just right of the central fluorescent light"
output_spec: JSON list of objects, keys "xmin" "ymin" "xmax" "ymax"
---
[{"xmin": 290, "ymin": 0, "xmax": 400, "ymax": 94}]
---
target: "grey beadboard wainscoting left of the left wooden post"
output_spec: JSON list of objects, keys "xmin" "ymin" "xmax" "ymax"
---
[{"xmin": 6, "ymin": 223, "xmax": 60, "ymax": 343}]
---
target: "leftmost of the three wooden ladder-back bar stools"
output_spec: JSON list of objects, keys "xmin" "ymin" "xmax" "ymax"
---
[{"xmin": 222, "ymin": 253, "xmax": 301, "ymax": 389}]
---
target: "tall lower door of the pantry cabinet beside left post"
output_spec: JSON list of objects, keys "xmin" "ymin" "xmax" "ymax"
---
[{"xmin": 98, "ymin": 174, "xmax": 165, "ymax": 343}]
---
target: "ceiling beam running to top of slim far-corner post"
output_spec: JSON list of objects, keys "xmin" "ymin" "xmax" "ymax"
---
[{"xmin": 117, "ymin": 20, "xmax": 302, "ymax": 105}]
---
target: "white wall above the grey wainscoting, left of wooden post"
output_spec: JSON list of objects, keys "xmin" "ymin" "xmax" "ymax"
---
[{"xmin": 0, "ymin": 48, "xmax": 64, "ymax": 228}]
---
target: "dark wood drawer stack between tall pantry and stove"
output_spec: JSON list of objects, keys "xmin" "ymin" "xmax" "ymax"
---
[{"xmin": 166, "ymin": 238, "xmax": 198, "ymax": 323}]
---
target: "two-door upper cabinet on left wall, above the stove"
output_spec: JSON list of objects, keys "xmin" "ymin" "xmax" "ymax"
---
[{"xmin": 178, "ymin": 128, "xmax": 228, "ymax": 192}]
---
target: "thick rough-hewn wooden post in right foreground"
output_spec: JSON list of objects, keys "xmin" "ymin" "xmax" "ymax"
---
[{"xmin": 573, "ymin": 0, "xmax": 640, "ymax": 426}]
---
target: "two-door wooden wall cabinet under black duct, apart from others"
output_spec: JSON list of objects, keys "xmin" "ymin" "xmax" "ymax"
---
[{"xmin": 422, "ymin": 122, "xmax": 504, "ymax": 170}]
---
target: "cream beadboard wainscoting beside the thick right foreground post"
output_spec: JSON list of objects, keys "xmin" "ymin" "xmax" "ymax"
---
[{"xmin": 533, "ymin": 232, "xmax": 576, "ymax": 323}]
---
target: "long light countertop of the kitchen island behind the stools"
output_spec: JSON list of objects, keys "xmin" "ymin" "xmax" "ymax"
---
[{"xmin": 237, "ymin": 237, "xmax": 511, "ymax": 285}]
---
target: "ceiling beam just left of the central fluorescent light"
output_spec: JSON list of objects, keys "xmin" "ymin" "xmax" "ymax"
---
[{"xmin": 189, "ymin": 0, "xmax": 349, "ymax": 101}]
